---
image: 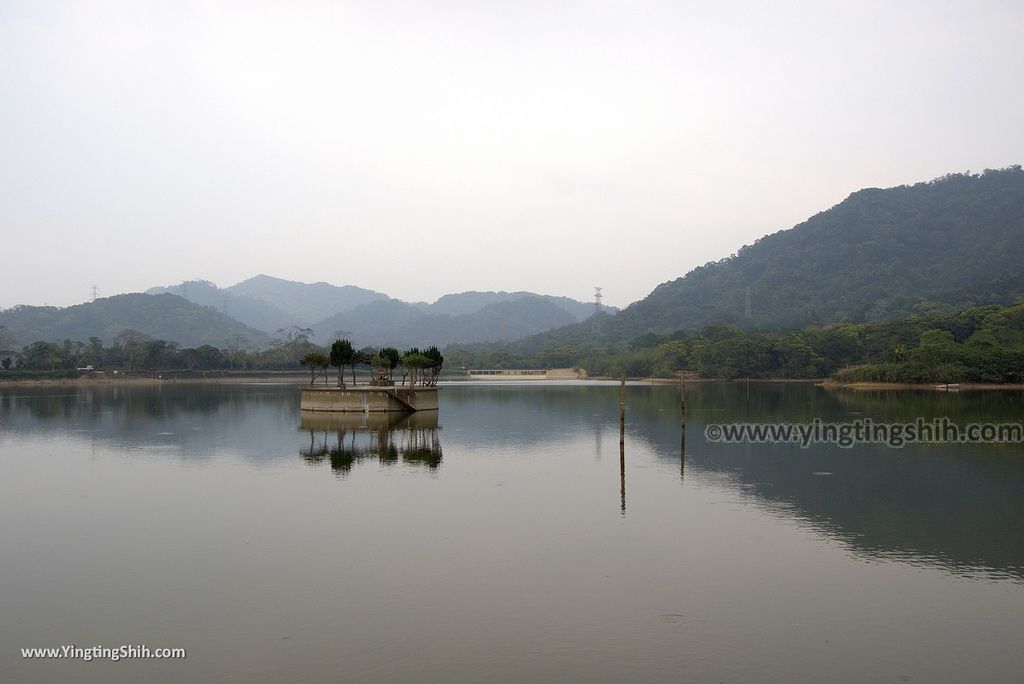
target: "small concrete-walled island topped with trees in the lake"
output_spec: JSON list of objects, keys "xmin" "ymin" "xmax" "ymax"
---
[{"xmin": 299, "ymin": 339, "xmax": 444, "ymax": 413}]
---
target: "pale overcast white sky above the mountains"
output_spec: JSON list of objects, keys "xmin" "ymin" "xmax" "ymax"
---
[{"xmin": 0, "ymin": 0, "xmax": 1024, "ymax": 307}]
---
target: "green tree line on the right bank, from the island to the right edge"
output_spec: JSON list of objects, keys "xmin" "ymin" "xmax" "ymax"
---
[{"xmin": 446, "ymin": 303, "xmax": 1024, "ymax": 383}]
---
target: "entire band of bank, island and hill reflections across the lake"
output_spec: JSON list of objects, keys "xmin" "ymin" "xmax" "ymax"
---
[{"xmin": 0, "ymin": 383, "xmax": 1024, "ymax": 580}]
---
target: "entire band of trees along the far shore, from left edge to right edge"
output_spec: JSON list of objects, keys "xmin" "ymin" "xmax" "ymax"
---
[{"xmin": 6, "ymin": 302, "xmax": 1024, "ymax": 389}]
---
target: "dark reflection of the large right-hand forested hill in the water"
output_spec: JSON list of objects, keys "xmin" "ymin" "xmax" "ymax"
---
[{"xmin": 629, "ymin": 383, "xmax": 1024, "ymax": 579}]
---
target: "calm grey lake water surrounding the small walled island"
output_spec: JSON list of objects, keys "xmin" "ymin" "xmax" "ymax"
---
[{"xmin": 0, "ymin": 383, "xmax": 1024, "ymax": 682}]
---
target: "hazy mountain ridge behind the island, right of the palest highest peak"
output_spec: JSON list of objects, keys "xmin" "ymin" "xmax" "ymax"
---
[{"xmin": 313, "ymin": 295, "xmax": 593, "ymax": 348}]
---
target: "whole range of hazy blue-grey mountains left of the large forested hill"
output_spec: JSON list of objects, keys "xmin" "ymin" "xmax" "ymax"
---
[{"xmin": 6, "ymin": 275, "xmax": 594, "ymax": 348}]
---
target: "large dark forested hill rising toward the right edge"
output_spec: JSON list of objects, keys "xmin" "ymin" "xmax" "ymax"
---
[{"xmin": 516, "ymin": 166, "xmax": 1024, "ymax": 348}]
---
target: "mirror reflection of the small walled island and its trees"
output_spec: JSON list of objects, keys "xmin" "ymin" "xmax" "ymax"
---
[{"xmin": 299, "ymin": 411, "xmax": 442, "ymax": 476}]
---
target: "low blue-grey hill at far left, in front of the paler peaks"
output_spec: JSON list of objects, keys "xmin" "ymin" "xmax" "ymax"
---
[{"xmin": 0, "ymin": 294, "xmax": 268, "ymax": 348}]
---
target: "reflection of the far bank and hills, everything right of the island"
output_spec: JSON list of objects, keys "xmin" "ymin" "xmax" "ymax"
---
[{"xmin": 442, "ymin": 383, "xmax": 1024, "ymax": 581}]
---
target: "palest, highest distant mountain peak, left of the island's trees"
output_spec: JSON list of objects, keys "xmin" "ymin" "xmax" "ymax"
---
[{"xmin": 224, "ymin": 274, "xmax": 388, "ymax": 327}]
